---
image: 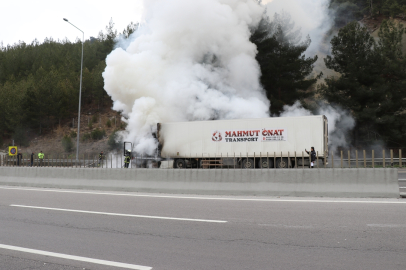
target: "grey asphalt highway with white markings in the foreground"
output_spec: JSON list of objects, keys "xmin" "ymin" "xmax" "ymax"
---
[{"xmin": 0, "ymin": 187, "xmax": 406, "ymax": 270}]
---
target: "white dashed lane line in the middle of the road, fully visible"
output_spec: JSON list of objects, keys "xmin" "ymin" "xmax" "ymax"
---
[{"xmin": 10, "ymin": 204, "xmax": 227, "ymax": 223}]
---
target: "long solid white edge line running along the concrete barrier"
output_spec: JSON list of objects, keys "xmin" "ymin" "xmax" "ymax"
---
[{"xmin": 0, "ymin": 187, "xmax": 406, "ymax": 204}]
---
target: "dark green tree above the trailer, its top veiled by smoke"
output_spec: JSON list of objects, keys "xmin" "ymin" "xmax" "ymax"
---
[{"xmin": 251, "ymin": 13, "xmax": 317, "ymax": 114}]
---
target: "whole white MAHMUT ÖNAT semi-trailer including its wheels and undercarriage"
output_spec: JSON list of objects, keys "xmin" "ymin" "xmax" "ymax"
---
[{"xmin": 157, "ymin": 115, "xmax": 328, "ymax": 168}]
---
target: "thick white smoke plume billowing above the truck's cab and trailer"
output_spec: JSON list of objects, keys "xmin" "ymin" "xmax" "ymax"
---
[{"xmin": 103, "ymin": 0, "xmax": 269, "ymax": 154}]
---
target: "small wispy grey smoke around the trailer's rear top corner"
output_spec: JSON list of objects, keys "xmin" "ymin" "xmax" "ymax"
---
[{"xmin": 281, "ymin": 101, "xmax": 355, "ymax": 153}]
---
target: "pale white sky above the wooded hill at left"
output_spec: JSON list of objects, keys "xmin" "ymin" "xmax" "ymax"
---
[{"xmin": 0, "ymin": 0, "xmax": 141, "ymax": 46}]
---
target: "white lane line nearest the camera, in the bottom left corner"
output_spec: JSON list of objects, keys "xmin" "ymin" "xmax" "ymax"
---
[{"xmin": 0, "ymin": 244, "xmax": 152, "ymax": 270}]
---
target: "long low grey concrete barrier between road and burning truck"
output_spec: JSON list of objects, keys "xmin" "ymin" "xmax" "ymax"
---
[{"xmin": 0, "ymin": 167, "xmax": 400, "ymax": 198}]
